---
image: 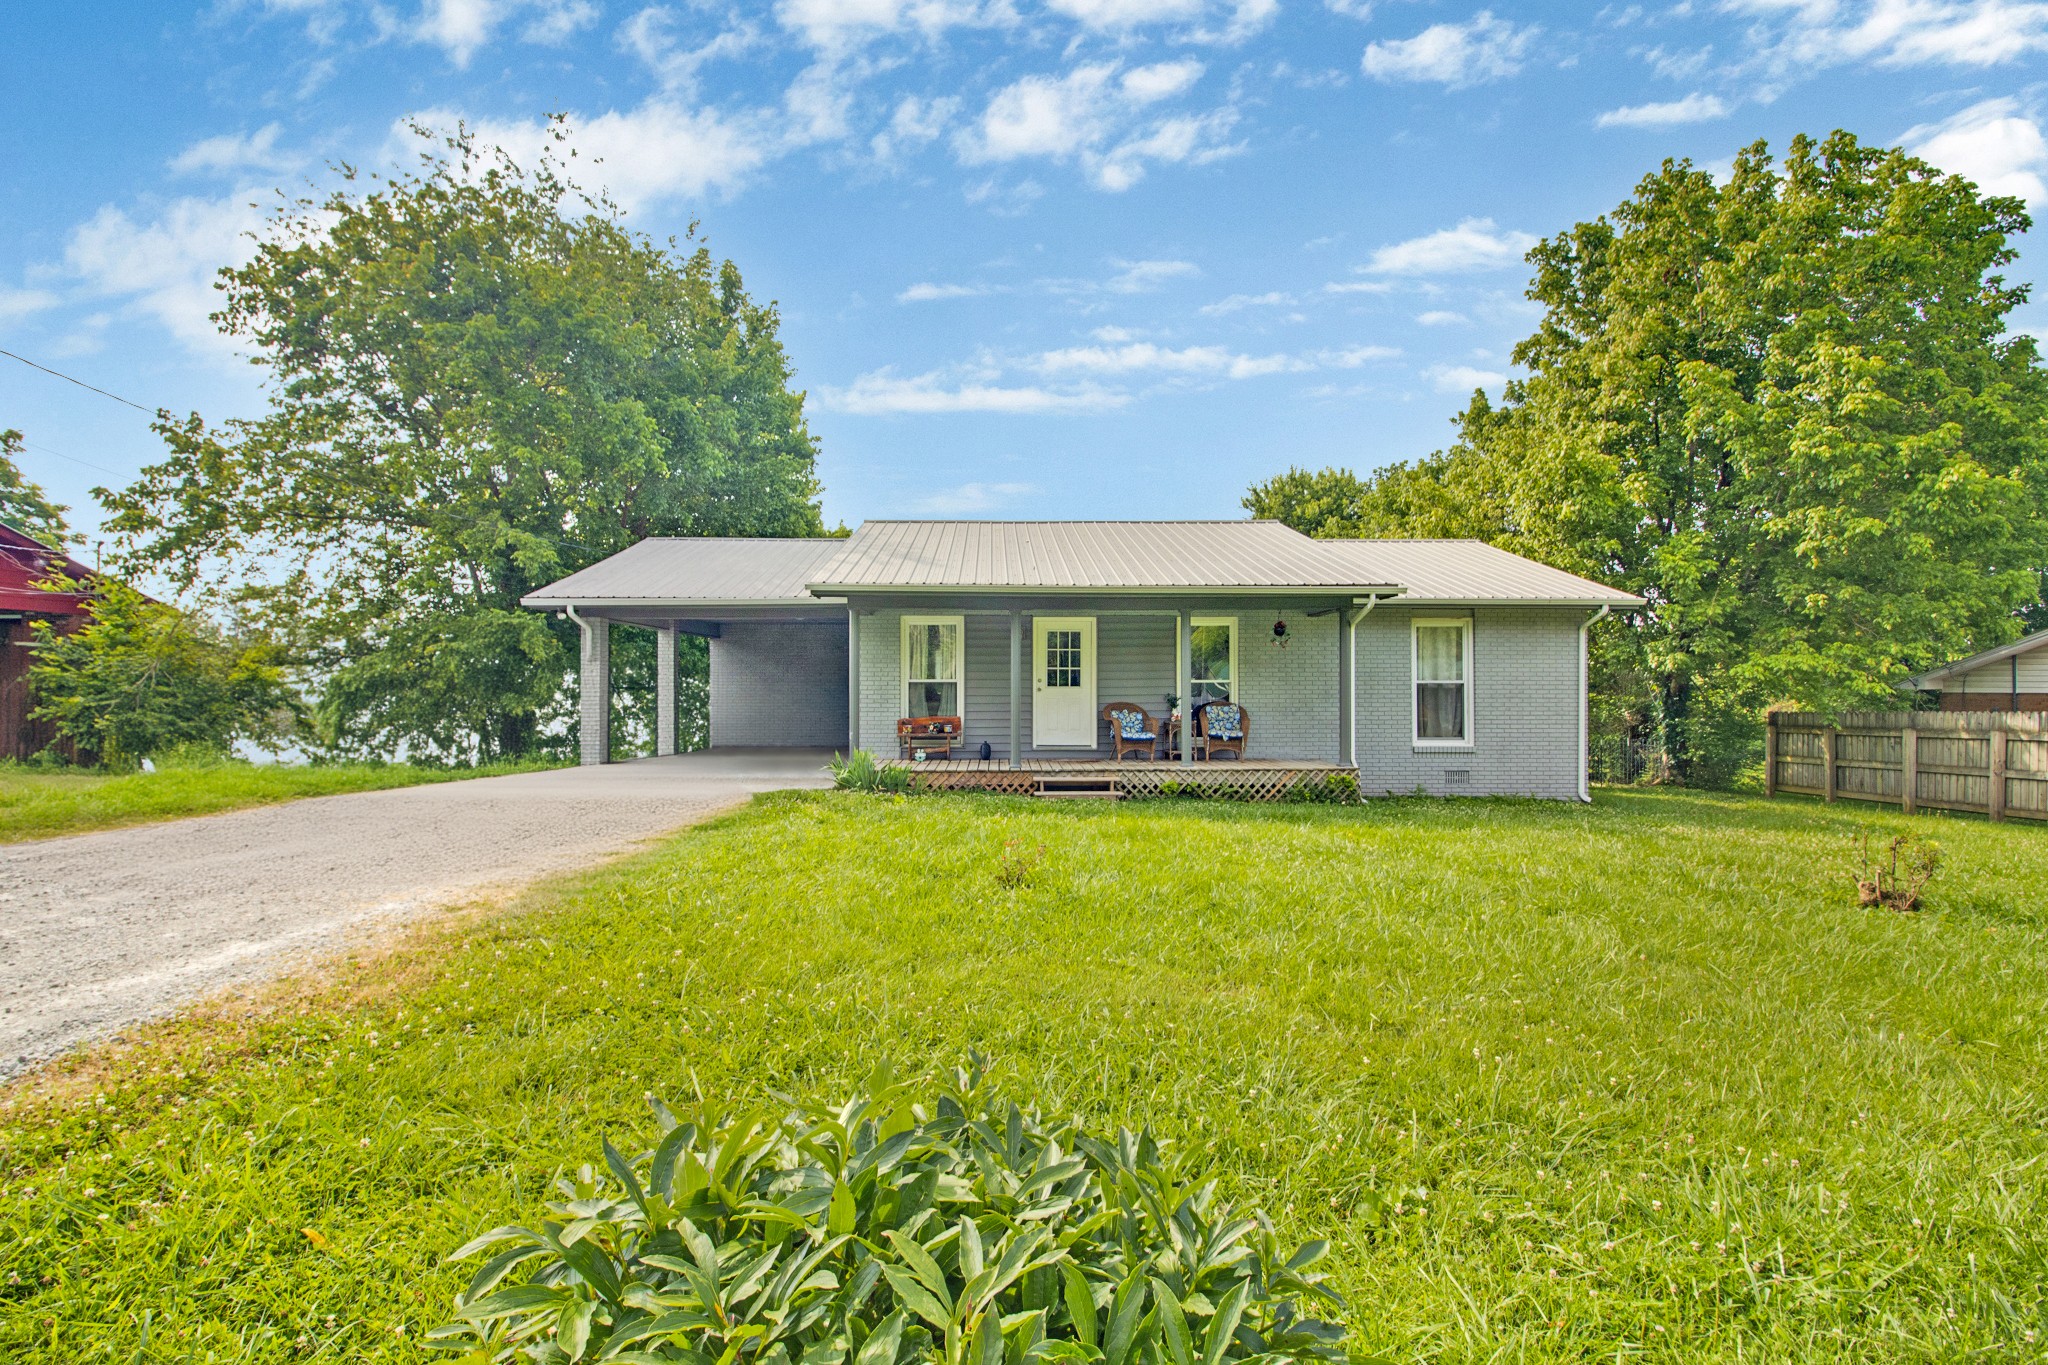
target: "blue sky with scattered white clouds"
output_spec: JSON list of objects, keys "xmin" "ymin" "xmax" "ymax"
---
[{"xmin": 0, "ymin": 0, "xmax": 2048, "ymax": 532}]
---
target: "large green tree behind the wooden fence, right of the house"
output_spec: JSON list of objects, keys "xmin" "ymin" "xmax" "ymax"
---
[{"xmin": 1247, "ymin": 133, "xmax": 2048, "ymax": 780}]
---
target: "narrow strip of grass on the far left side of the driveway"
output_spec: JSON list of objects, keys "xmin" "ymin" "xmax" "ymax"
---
[{"xmin": 0, "ymin": 763, "xmax": 551, "ymax": 843}]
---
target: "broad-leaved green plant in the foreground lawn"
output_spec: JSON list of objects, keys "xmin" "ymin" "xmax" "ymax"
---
[{"xmin": 430, "ymin": 1058, "xmax": 1343, "ymax": 1365}]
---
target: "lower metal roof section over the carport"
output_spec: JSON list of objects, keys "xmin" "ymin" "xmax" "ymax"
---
[{"xmin": 520, "ymin": 536, "xmax": 846, "ymax": 608}]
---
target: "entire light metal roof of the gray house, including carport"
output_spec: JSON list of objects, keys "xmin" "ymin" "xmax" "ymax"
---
[{"xmin": 524, "ymin": 522, "xmax": 1640, "ymax": 608}]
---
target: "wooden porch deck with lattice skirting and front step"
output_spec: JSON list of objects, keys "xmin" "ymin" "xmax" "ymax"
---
[{"xmin": 887, "ymin": 757, "xmax": 1352, "ymax": 800}]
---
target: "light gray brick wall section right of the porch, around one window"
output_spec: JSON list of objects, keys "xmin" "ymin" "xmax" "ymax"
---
[{"xmin": 1358, "ymin": 606, "xmax": 1587, "ymax": 800}]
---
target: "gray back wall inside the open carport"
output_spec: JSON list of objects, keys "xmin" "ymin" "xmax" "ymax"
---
[{"xmin": 711, "ymin": 622, "xmax": 846, "ymax": 749}]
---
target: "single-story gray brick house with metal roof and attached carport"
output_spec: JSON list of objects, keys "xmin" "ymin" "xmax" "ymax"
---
[{"xmin": 524, "ymin": 520, "xmax": 1640, "ymax": 800}]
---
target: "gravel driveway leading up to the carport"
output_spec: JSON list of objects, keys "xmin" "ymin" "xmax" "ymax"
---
[{"xmin": 0, "ymin": 749, "xmax": 829, "ymax": 1078}]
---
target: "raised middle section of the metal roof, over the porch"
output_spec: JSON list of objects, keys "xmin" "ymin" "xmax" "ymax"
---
[{"xmin": 811, "ymin": 522, "xmax": 1399, "ymax": 593}]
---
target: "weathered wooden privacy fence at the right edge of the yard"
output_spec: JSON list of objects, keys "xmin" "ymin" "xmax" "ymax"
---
[{"xmin": 1763, "ymin": 710, "xmax": 2048, "ymax": 821}]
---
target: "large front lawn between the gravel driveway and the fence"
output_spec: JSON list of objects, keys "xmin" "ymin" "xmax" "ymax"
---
[{"xmin": 0, "ymin": 792, "xmax": 2048, "ymax": 1363}]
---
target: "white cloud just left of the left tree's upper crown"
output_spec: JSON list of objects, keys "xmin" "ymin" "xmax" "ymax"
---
[{"xmin": 63, "ymin": 190, "xmax": 264, "ymax": 354}]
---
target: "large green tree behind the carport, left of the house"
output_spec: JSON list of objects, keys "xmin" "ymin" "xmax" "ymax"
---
[{"xmin": 100, "ymin": 131, "xmax": 823, "ymax": 759}]
